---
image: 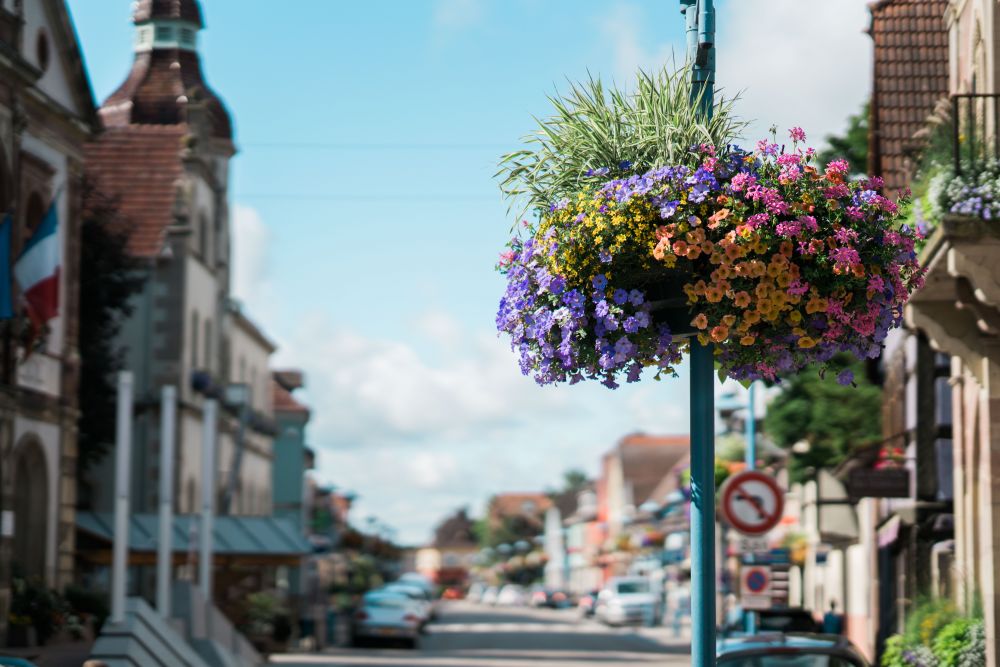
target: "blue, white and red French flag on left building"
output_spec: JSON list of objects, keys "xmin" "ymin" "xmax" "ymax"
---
[{"xmin": 14, "ymin": 204, "xmax": 62, "ymax": 326}]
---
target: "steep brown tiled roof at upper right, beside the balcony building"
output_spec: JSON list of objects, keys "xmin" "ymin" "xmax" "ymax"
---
[{"xmin": 869, "ymin": 0, "xmax": 948, "ymax": 191}]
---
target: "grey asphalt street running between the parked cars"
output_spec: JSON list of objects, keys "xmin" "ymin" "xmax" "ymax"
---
[{"xmin": 272, "ymin": 602, "xmax": 691, "ymax": 667}]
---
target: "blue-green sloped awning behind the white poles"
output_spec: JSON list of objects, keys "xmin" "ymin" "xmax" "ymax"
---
[{"xmin": 76, "ymin": 512, "xmax": 312, "ymax": 561}]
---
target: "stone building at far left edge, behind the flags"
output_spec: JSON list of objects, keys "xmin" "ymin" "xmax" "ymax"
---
[{"xmin": 0, "ymin": 0, "xmax": 96, "ymax": 635}]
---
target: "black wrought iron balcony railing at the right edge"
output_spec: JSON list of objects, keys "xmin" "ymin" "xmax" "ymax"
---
[{"xmin": 951, "ymin": 93, "xmax": 1000, "ymax": 174}]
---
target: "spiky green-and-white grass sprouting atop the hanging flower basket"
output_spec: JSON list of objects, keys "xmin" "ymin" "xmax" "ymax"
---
[{"xmin": 497, "ymin": 67, "xmax": 746, "ymax": 214}]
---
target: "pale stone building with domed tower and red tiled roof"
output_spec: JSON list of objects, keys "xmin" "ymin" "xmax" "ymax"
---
[{"xmin": 87, "ymin": 0, "xmax": 274, "ymax": 515}]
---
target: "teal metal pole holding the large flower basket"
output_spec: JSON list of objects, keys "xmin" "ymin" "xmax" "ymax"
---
[{"xmin": 681, "ymin": 0, "xmax": 717, "ymax": 667}]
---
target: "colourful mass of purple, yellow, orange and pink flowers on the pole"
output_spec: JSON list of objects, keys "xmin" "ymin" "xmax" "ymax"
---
[{"xmin": 497, "ymin": 128, "xmax": 923, "ymax": 388}]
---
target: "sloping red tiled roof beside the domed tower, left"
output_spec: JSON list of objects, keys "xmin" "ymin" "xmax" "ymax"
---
[{"xmin": 86, "ymin": 125, "xmax": 187, "ymax": 257}]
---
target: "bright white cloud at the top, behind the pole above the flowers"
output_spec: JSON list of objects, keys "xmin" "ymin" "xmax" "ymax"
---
[{"xmin": 599, "ymin": 0, "xmax": 871, "ymax": 147}]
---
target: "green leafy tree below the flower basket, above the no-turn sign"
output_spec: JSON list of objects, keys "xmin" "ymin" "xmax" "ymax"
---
[{"xmin": 765, "ymin": 355, "xmax": 882, "ymax": 481}]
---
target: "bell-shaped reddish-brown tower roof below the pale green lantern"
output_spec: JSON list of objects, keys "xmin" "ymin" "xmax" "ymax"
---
[{"xmin": 99, "ymin": 49, "xmax": 233, "ymax": 139}]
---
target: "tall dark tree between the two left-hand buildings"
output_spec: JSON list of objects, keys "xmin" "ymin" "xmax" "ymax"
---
[{"xmin": 77, "ymin": 180, "xmax": 144, "ymax": 472}]
